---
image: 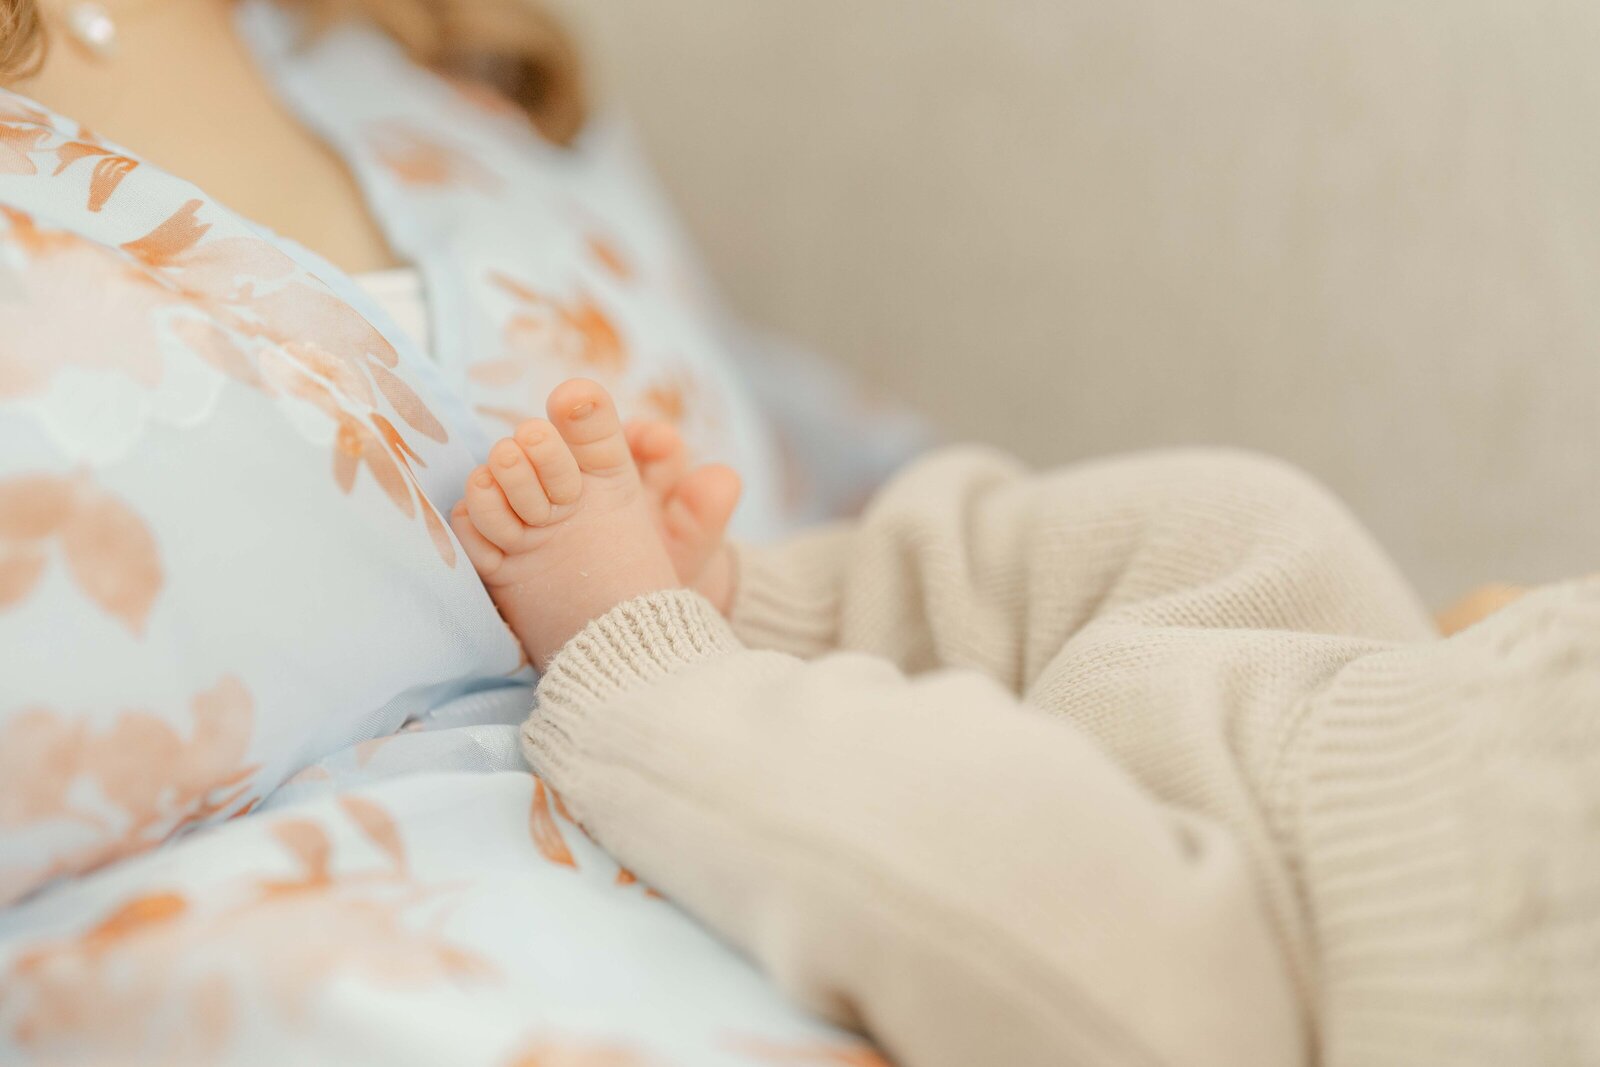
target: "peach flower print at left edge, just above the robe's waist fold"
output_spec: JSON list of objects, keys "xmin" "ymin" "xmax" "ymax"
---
[{"xmin": 0, "ymin": 677, "xmax": 258, "ymax": 904}]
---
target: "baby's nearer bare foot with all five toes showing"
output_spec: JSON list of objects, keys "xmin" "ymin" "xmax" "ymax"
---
[{"xmin": 450, "ymin": 379, "xmax": 736, "ymax": 669}]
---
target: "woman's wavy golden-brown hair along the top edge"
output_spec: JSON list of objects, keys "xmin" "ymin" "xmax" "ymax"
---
[{"xmin": 0, "ymin": 0, "xmax": 589, "ymax": 144}]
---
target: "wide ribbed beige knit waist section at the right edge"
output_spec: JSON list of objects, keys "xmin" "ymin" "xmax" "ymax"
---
[{"xmin": 1293, "ymin": 584, "xmax": 1600, "ymax": 1065}]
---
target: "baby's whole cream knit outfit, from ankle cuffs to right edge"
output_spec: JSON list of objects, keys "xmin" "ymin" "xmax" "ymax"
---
[{"xmin": 525, "ymin": 451, "xmax": 1600, "ymax": 1067}]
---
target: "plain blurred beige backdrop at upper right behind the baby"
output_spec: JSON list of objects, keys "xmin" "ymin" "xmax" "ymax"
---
[{"xmin": 565, "ymin": 0, "xmax": 1600, "ymax": 600}]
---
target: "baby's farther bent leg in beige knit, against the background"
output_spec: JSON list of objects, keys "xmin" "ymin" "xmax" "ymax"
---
[{"xmin": 733, "ymin": 448, "xmax": 1435, "ymax": 693}]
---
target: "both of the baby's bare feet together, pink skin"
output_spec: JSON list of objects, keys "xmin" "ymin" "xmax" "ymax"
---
[{"xmin": 450, "ymin": 378, "xmax": 739, "ymax": 670}]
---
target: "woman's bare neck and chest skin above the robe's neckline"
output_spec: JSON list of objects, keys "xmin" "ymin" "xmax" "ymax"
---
[{"xmin": 20, "ymin": 0, "xmax": 398, "ymax": 274}]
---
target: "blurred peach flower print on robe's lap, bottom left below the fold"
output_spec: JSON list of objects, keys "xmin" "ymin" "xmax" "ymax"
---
[{"xmin": 0, "ymin": 795, "xmax": 494, "ymax": 1062}]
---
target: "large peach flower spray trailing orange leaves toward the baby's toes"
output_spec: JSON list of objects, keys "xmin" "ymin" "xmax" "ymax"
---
[{"xmin": 26, "ymin": 200, "xmax": 456, "ymax": 566}]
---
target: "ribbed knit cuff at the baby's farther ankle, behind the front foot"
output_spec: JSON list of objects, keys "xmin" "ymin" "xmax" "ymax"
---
[{"xmin": 728, "ymin": 525, "xmax": 851, "ymax": 659}]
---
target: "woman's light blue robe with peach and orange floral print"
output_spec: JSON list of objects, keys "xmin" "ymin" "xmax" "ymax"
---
[{"xmin": 0, "ymin": 3, "xmax": 896, "ymax": 1064}]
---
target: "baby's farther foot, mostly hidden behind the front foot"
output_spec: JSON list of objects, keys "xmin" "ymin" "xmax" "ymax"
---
[{"xmin": 624, "ymin": 419, "xmax": 739, "ymax": 614}]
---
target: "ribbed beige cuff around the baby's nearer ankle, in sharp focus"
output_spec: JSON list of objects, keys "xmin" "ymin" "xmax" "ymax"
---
[{"xmin": 522, "ymin": 589, "xmax": 739, "ymax": 781}]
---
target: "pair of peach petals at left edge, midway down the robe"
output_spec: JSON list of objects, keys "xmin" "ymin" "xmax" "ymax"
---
[{"xmin": 0, "ymin": 474, "xmax": 163, "ymax": 637}]
